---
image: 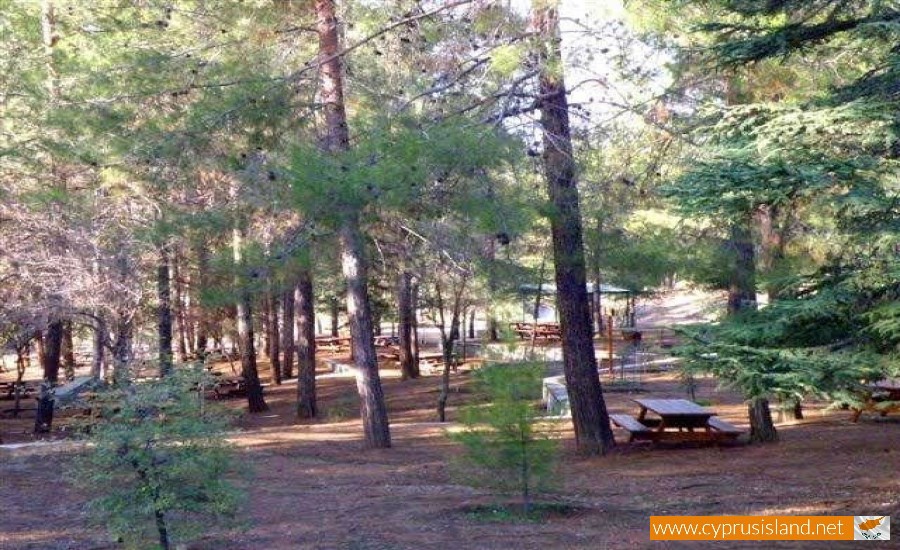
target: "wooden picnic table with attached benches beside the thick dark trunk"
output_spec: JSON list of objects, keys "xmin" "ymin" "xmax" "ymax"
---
[{"xmin": 610, "ymin": 399, "xmax": 743, "ymax": 443}]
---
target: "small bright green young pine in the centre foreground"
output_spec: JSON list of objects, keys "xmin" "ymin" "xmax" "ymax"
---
[{"xmin": 453, "ymin": 363, "xmax": 557, "ymax": 515}]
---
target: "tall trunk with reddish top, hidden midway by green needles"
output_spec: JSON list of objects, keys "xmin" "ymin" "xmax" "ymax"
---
[{"xmin": 315, "ymin": 0, "xmax": 391, "ymax": 448}]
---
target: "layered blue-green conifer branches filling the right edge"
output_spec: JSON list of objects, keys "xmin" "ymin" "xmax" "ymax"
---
[{"xmin": 644, "ymin": 0, "xmax": 900, "ymax": 414}]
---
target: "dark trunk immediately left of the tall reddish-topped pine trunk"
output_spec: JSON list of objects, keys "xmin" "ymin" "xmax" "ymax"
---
[{"xmin": 294, "ymin": 269, "xmax": 318, "ymax": 418}]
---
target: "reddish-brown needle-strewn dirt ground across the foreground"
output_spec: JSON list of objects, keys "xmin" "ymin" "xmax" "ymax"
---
[{"xmin": 0, "ymin": 342, "xmax": 900, "ymax": 550}]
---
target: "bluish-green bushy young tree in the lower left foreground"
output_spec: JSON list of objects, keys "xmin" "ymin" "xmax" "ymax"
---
[{"xmin": 70, "ymin": 367, "xmax": 243, "ymax": 548}]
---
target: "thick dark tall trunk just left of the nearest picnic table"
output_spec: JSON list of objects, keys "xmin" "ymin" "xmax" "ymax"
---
[{"xmin": 532, "ymin": 0, "xmax": 615, "ymax": 455}]
